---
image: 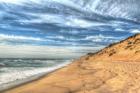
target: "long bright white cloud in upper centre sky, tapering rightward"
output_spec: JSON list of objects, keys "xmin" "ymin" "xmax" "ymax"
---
[{"xmin": 18, "ymin": 13, "xmax": 109, "ymax": 28}]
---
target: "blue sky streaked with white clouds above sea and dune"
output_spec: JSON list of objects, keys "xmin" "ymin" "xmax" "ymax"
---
[{"xmin": 0, "ymin": 0, "xmax": 140, "ymax": 58}]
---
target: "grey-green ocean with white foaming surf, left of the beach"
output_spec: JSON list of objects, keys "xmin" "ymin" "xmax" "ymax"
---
[{"xmin": 0, "ymin": 58, "xmax": 71, "ymax": 90}]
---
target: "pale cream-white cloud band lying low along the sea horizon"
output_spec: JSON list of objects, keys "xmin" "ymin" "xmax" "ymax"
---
[{"xmin": 0, "ymin": 44, "xmax": 102, "ymax": 58}]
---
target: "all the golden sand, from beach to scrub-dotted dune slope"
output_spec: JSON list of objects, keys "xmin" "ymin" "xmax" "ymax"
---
[{"xmin": 4, "ymin": 34, "xmax": 140, "ymax": 93}]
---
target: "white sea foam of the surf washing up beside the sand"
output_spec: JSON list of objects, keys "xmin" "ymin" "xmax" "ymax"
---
[{"xmin": 0, "ymin": 61, "xmax": 70, "ymax": 91}]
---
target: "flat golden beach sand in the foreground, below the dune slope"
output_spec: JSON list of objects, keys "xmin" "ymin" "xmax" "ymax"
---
[{"xmin": 3, "ymin": 62, "xmax": 140, "ymax": 93}]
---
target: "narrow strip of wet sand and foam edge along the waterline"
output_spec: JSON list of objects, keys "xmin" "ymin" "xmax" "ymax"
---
[{"xmin": 0, "ymin": 61, "xmax": 71, "ymax": 93}]
